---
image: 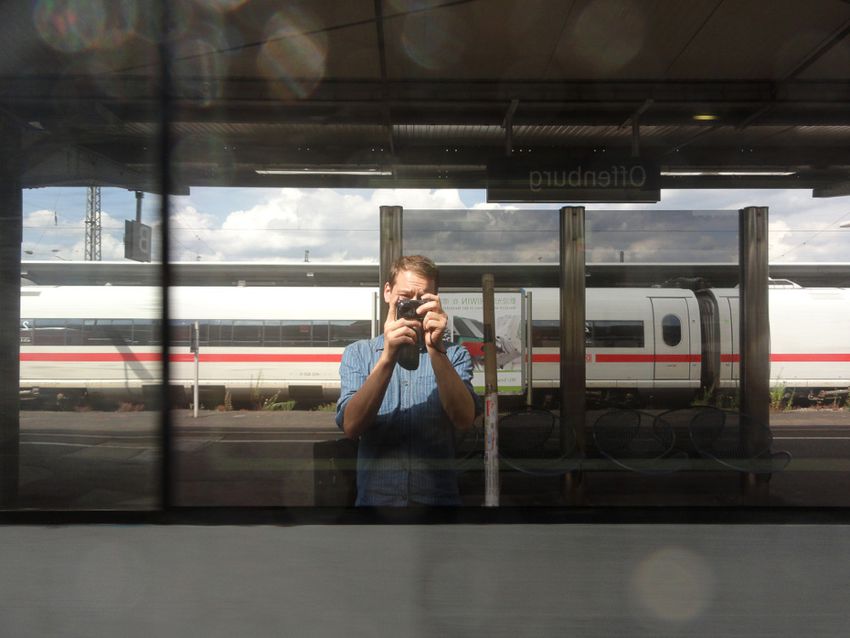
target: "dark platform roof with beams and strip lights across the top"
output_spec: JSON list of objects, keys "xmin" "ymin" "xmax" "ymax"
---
[{"xmin": 0, "ymin": 0, "xmax": 850, "ymax": 196}]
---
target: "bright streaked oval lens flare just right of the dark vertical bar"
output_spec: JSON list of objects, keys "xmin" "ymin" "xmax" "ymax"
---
[{"xmin": 257, "ymin": 10, "xmax": 328, "ymax": 99}]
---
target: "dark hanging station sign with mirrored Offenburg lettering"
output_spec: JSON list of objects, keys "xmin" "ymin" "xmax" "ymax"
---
[{"xmin": 487, "ymin": 153, "xmax": 661, "ymax": 203}]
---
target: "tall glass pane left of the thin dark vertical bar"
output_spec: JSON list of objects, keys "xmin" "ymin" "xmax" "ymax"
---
[{"xmin": 14, "ymin": 2, "xmax": 163, "ymax": 510}]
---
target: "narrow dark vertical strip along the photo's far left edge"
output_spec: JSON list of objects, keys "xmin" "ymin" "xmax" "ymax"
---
[{"xmin": 0, "ymin": 122, "xmax": 23, "ymax": 508}]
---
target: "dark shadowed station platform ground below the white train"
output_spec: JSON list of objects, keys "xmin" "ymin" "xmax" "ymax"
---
[{"xmin": 11, "ymin": 410, "xmax": 850, "ymax": 510}]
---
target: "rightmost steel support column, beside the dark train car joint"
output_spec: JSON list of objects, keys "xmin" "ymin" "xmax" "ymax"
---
[{"xmin": 738, "ymin": 206, "xmax": 770, "ymax": 492}]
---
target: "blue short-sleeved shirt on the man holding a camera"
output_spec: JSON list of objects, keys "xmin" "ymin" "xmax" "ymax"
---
[{"xmin": 336, "ymin": 335, "xmax": 480, "ymax": 506}]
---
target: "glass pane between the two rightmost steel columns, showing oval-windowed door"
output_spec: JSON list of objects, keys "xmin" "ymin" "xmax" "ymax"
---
[{"xmin": 585, "ymin": 208, "xmax": 741, "ymax": 506}]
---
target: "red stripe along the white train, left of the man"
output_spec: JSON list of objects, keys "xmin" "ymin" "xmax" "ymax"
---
[{"xmin": 21, "ymin": 352, "xmax": 342, "ymax": 363}]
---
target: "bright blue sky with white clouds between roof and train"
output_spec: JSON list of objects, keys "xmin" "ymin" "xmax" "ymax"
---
[{"xmin": 22, "ymin": 188, "xmax": 850, "ymax": 263}]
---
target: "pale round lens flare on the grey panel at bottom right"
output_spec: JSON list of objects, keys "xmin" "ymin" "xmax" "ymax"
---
[{"xmin": 631, "ymin": 547, "xmax": 715, "ymax": 623}]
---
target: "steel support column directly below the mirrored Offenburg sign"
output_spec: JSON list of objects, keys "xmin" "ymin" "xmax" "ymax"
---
[{"xmin": 560, "ymin": 206, "xmax": 587, "ymax": 500}]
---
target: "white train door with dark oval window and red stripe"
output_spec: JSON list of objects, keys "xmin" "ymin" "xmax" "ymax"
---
[{"xmin": 651, "ymin": 297, "xmax": 692, "ymax": 381}]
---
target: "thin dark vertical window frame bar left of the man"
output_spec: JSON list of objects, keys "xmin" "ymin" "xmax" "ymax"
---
[{"xmin": 159, "ymin": 0, "xmax": 175, "ymax": 510}]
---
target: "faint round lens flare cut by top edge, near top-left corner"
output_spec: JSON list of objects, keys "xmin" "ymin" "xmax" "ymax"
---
[{"xmin": 33, "ymin": 0, "xmax": 138, "ymax": 53}]
